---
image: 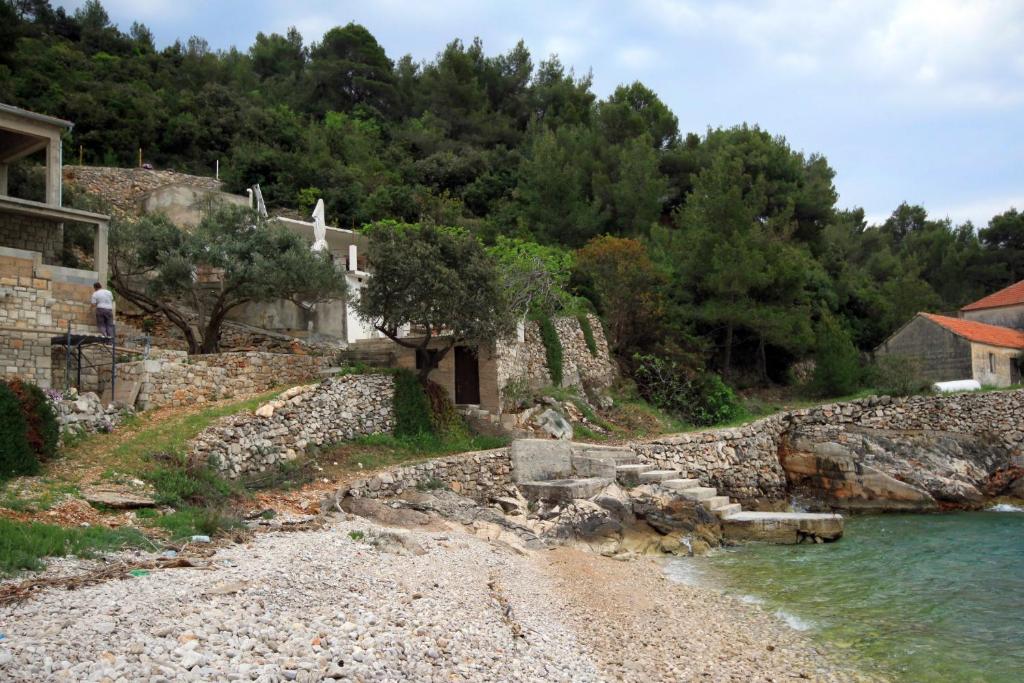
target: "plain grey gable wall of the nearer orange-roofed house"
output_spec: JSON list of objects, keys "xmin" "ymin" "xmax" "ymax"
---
[{"xmin": 876, "ymin": 316, "xmax": 974, "ymax": 382}]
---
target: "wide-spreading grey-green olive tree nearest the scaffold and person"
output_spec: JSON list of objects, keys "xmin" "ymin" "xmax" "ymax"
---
[{"xmin": 111, "ymin": 207, "xmax": 345, "ymax": 353}]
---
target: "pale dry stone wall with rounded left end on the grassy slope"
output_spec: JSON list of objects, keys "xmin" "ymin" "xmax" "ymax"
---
[{"xmin": 190, "ymin": 375, "xmax": 394, "ymax": 478}]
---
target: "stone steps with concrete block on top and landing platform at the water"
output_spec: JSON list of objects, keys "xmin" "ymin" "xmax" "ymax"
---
[{"xmin": 512, "ymin": 439, "xmax": 843, "ymax": 544}]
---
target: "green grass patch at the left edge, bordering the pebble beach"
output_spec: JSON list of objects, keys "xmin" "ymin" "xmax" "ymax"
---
[{"xmin": 0, "ymin": 518, "xmax": 150, "ymax": 574}]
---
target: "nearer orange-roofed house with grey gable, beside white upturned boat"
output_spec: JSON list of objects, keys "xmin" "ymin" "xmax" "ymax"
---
[{"xmin": 874, "ymin": 313, "xmax": 1024, "ymax": 387}]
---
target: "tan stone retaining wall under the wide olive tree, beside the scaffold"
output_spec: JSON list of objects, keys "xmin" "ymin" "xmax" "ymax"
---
[{"xmin": 118, "ymin": 351, "xmax": 331, "ymax": 410}]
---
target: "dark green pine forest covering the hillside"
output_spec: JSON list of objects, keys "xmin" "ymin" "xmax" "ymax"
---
[{"xmin": 0, "ymin": 0, "xmax": 1024, "ymax": 393}]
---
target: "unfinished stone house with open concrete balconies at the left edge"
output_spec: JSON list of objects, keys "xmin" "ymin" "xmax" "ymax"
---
[{"xmin": 0, "ymin": 103, "xmax": 109, "ymax": 387}]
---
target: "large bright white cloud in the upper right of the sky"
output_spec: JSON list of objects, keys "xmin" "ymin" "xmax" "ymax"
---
[{"xmin": 640, "ymin": 0, "xmax": 1024, "ymax": 106}]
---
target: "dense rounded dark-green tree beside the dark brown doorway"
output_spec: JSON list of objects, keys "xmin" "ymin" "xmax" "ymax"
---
[{"xmin": 355, "ymin": 221, "xmax": 514, "ymax": 384}]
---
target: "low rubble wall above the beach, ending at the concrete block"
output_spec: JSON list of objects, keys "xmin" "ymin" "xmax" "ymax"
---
[{"xmin": 348, "ymin": 447, "xmax": 512, "ymax": 502}]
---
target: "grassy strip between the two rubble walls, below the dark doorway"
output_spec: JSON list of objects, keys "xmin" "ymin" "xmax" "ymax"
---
[{"xmin": 321, "ymin": 434, "xmax": 509, "ymax": 471}]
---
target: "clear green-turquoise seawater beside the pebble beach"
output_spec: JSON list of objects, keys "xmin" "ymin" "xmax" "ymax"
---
[{"xmin": 668, "ymin": 512, "xmax": 1024, "ymax": 683}]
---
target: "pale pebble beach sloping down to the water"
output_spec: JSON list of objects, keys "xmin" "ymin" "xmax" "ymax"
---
[{"xmin": 0, "ymin": 518, "xmax": 872, "ymax": 683}]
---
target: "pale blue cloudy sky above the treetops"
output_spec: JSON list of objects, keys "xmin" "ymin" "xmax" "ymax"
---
[{"xmin": 54, "ymin": 0, "xmax": 1024, "ymax": 227}]
